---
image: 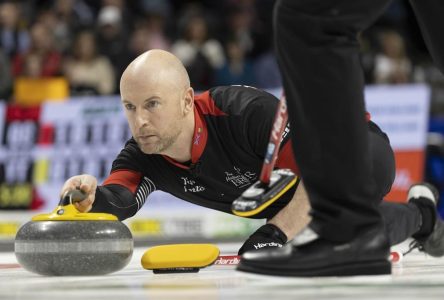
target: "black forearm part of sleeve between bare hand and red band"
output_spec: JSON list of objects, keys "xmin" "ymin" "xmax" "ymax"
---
[{"xmin": 91, "ymin": 184, "xmax": 139, "ymax": 221}]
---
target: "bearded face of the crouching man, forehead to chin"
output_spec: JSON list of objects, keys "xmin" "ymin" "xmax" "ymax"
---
[{"xmin": 121, "ymin": 82, "xmax": 184, "ymax": 154}]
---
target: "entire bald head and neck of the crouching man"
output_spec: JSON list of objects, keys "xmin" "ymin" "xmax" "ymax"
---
[{"xmin": 120, "ymin": 50, "xmax": 194, "ymax": 161}]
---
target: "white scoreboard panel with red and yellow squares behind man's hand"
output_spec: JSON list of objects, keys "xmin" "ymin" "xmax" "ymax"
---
[{"xmin": 33, "ymin": 96, "xmax": 131, "ymax": 207}]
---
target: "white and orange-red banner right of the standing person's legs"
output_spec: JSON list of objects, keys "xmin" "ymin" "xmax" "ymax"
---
[{"xmin": 365, "ymin": 85, "xmax": 430, "ymax": 202}]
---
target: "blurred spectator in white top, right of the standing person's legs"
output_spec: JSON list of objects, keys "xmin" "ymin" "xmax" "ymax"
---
[{"xmin": 374, "ymin": 30, "xmax": 412, "ymax": 84}]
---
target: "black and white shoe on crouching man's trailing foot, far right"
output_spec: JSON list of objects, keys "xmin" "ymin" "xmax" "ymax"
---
[{"xmin": 404, "ymin": 183, "xmax": 444, "ymax": 257}]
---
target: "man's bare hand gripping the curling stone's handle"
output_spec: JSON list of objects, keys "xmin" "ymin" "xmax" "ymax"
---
[{"xmin": 60, "ymin": 174, "xmax": 97, "ymax": 212}]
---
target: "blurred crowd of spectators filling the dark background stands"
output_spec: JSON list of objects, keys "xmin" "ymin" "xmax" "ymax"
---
[{"xmin": 0, "ymin": 0, "xmax": 444, "ymax": 101}]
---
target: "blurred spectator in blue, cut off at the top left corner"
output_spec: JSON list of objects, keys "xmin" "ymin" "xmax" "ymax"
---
[{"xmin": 0, "ymin": 1, "xmax": 29, "ymax": 58}]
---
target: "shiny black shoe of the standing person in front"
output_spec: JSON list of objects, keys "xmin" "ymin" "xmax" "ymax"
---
[{"xmin": 237, "ymin": 226, "xmax": 391, "ymax": 277}]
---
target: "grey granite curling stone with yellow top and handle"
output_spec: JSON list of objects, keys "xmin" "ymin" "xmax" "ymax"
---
[{"xmin": 14, "ymin": 190, "xmax": 133, "ymax": 276}]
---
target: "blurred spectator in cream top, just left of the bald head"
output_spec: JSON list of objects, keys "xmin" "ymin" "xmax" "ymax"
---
[{"xmin": 64, "ymin": 31, "xmax": 116, "ymax": 95}]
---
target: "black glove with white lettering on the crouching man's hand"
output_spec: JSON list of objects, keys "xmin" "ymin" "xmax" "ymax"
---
[{"xmin": 238, "ymin": 223, "xmax": 287, "ymax": 255}]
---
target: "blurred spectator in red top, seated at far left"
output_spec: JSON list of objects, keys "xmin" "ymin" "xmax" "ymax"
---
[{"xmin": 12, "ymin": 23, "xmax": 62, "ymax": 77}]
